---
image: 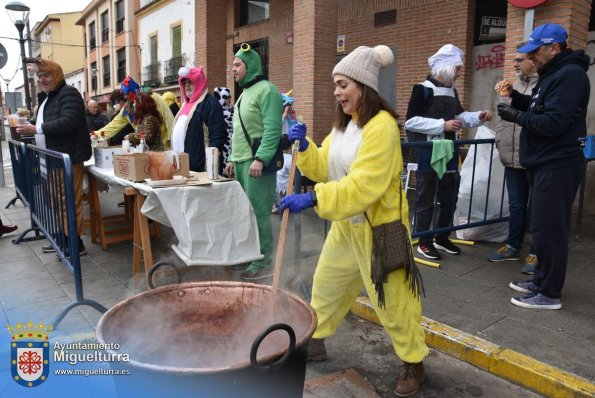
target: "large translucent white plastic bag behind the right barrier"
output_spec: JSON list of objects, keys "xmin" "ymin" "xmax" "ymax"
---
[{"xmin": 454, "ymin": 126, "xmax": 509, "ymax": 242}]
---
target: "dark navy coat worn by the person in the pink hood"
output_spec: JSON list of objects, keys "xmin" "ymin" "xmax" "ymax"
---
[{"xmin": 184, "ymin": 94, "xmax": 227, "ymax": 171}]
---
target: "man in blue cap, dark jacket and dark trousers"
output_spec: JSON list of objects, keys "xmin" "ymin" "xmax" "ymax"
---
[{"xmin": 498, "ymin": 24, "xmax": 590, "ymax": 309}]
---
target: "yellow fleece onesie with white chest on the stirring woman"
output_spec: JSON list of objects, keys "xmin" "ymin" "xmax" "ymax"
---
[{"xmin": 297, "ymin": 111, "xmax": 429, "ymax": 363}]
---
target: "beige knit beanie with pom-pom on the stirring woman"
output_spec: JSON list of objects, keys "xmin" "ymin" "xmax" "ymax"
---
[{"xmin": 333, "ymin": 45, "xmax": 394, "ymax": 92}]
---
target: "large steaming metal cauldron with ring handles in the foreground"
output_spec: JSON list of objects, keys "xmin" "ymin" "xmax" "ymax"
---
[{"xmin": 97, "ymin": 282, "xmax": 317, "ymax": 398}]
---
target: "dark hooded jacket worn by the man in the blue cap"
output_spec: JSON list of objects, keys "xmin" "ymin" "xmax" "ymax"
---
[{"xmin": 512, "ymin": 49, "xmax": 591, "ymax": 170}]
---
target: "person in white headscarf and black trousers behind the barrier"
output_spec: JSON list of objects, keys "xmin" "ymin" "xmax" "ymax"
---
[{"xmin": 405, "ymin": 44, "xmax": 492, "ymax": 259}]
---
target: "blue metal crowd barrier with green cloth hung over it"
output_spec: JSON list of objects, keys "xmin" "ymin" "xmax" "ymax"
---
[{"xmin": 401, "ymin": 139, "xmax": 508, "ymax": 238}]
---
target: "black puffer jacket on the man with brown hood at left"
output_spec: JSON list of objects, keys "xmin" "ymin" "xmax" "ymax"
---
[{"xmin": 37, "ymin": 80, "xmax": 92, "ymax": 163}]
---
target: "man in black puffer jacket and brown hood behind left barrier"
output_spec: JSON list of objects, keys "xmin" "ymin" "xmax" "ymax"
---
[{"xmin": 17, "ymin": 59, "xmax": 92, "ymax": 254}]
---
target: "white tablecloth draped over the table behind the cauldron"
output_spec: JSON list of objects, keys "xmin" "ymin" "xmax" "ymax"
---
[{"xmin": 87, "ymin": 165, "xmax": 262, "ymax": 265}]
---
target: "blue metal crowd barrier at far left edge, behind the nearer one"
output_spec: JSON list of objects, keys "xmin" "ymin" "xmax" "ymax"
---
[{"xmin": 5, "ymin": 139, "xmax": 43, "ymax": 245}]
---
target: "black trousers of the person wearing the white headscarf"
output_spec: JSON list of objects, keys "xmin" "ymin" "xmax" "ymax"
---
[{"xmin": 415, "ymin": 171, "xmax": 459, "ymax": 244}]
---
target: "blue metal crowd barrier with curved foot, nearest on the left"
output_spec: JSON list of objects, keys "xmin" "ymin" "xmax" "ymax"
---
[{"xmin": 27, "ymin": 144, "xmax": 107, "ymax": 328}]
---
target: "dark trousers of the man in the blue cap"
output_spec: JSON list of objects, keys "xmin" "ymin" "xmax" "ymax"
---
[{"xmin": 527, "ymin": 163, "xmax": 585, "ymax": 298}]
